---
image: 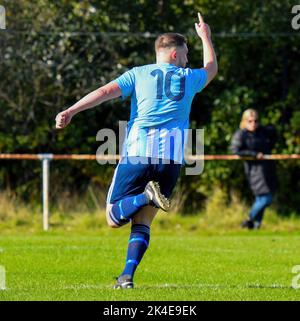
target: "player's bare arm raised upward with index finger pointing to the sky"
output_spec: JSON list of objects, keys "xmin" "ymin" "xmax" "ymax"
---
[{"xmin": 195, "ymin": 12, "xmax": 218, "ymax": 85}]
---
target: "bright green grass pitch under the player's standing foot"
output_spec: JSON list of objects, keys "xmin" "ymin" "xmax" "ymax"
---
[{"xmin": 0, "ymin": 229, "xmax": 300, "ymax": 301}]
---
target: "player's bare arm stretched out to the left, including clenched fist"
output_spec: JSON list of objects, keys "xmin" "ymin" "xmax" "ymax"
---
[{"xmin": 55, "ymin": 82, "xmax": 121, "ymax": 129}]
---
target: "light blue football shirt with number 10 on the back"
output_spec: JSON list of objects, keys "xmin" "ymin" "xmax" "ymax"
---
[{"xmin": 114, "ymin": 63, "xmax": 207, "ymax": 163}]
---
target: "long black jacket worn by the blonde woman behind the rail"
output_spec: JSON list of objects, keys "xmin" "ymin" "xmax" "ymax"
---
[{"xmin": 231, "ymin": 126, "xmax": 276, "ymax": 195}]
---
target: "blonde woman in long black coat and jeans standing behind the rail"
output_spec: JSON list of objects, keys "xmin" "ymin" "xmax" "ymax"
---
[{"xmin": 231, "ymin": 109, "xmax": 276, "ymax": 229}]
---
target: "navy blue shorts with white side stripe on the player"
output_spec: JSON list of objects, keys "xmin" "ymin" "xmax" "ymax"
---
[{"xmin": 106, "ymin": 156, "xmax": 182, "ymax": 204}]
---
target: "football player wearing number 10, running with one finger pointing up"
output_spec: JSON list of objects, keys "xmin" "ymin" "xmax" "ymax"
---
[{"xmin": 56, "ymin": 13, "xmax": 218, "ymax": 288}]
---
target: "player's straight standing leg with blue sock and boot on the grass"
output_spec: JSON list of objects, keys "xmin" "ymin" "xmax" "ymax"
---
[{"xmin": 115, "ymin": 206, "xmax": 158, "ymax": 288}]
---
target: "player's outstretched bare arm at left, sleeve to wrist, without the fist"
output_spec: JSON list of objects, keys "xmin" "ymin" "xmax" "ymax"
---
[{"xmin": 68, "ymin": 83, "xmax": 121, "ymax": 116}]
